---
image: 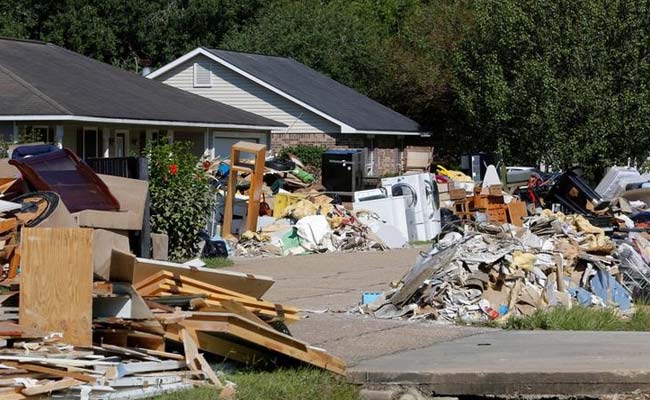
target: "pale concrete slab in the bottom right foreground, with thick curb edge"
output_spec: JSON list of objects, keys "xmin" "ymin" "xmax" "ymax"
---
[{"xmin": 348, "ymin": 331, "xmax": 650, "ymax": 396}]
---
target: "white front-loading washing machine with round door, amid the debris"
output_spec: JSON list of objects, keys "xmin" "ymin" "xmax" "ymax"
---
[{"xmin": 381, "ymin": 172, "xmax": 441, "ymax": 240}]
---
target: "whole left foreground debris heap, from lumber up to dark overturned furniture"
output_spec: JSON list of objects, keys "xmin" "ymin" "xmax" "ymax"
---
[{"xmin": 0, "ymin": 146, "xmax": 345, "ymax": 399}]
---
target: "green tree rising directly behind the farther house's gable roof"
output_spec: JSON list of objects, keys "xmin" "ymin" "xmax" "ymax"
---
[{"xmin": 222, "ymin": 0, "xmax": 387, "ymax": 99}]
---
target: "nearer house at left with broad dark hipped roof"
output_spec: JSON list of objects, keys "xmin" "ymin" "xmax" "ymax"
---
[{"xmin": 0, "ymin": 39, "xmax": 285, "ymax": 158}]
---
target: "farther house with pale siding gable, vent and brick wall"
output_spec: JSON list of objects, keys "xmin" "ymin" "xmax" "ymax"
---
[{"xmin": 147, "ymin": 47, "xmax": 429, "ymax": 175}]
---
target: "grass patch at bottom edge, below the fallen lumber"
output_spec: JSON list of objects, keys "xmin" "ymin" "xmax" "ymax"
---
[{"xmin": 149, "ymin": 368, "xmax": 360, "ymax": 400}]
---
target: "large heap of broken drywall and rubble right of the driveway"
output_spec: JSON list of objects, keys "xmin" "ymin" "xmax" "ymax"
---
[{"xmin": 360, "ymin": 210, "xmax": 650, "ymax": 322}]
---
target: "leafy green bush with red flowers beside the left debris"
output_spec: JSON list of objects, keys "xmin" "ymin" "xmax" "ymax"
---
[{"xmin": 146, "ymin": 142, "xmax": 213, "ymax": 260}]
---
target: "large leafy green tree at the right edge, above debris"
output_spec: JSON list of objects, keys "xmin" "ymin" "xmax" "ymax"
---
[{"xmin": 454, "ymin": 0, "xmax": 650, "ymax": 175}]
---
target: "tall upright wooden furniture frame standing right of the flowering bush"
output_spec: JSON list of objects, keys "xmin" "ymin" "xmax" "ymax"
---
[{"xmin": 221, "ymin": 142, "xmax": 266, "ymax": 238}]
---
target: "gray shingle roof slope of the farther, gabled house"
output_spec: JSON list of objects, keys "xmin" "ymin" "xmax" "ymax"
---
[{"xmin": 203, "ymin": 48, "xmax": 421, "ymax": 132}]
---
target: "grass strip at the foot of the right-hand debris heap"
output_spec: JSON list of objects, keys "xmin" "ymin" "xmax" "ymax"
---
[{"xmin": 492, "ymin": 306, "xmax": 650, "ymax": 331}]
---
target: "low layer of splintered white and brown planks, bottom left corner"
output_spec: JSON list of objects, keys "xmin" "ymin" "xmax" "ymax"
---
[{"xmin": 0, "ymin": 322, "xmax": 203, "ymax": 400}]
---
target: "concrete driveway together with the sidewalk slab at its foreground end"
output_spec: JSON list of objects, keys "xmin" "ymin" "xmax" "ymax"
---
[{"xmin": 233, "ymin": 249, "xmax": 650, "ymax": 396}]
